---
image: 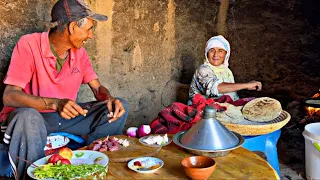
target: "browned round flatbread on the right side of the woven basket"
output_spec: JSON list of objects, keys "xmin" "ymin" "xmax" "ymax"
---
[{"xmin": 242, "ymin": 97, "xmax": 282, "ymax": 122}]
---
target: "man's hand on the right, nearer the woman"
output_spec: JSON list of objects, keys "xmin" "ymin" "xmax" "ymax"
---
[{"xmin": 107, "ymin": 98, "xmax": 126, "ymax": 123}]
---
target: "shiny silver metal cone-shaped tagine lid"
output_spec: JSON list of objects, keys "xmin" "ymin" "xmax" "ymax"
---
[{"xmin": 180, "ymin": 106, "xmax": 240, "ymax": 150}]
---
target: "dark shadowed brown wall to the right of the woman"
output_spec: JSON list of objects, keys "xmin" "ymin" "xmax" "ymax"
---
[{"xmin": 228, "ymin": 0, "xmax": 320, "ymax": 105}]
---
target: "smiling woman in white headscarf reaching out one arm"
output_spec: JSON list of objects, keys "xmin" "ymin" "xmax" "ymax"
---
[{"xmin": 188, "ymin": 35, "xmax": 262, "ymax": 105}]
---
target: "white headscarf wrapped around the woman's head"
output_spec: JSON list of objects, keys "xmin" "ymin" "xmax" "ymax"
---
[{"xmin": 205, "ymin": 35, "xmax": 231, "ymax": 67}]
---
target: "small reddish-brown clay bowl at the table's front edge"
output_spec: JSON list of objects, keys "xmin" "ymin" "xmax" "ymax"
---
[{"xmin": 181, "ymin": 156, "xmax": 217, "ymax": 180}]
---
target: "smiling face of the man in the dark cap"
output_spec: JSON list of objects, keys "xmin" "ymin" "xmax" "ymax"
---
[{"xmin": 70, "ymin": 19, "xmax": 94, "ymax": 49}]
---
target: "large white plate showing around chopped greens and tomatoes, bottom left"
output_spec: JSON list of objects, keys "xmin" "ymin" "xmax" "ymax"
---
[{"xmin": 27, "ymin": 150, "xmax": 109, "ymax": 180}]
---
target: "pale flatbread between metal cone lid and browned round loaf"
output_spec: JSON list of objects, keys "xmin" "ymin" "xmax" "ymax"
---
[{"xmin": 216, "ymin": 103, "xmax": 244, "ymax": 124}]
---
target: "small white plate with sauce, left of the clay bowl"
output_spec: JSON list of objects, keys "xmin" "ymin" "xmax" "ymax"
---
[{"xmin": 128, "ymin": 157, "xmax": 164, "ymax": 173}]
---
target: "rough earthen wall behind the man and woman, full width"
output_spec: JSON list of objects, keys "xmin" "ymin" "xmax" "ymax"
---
[{"xmin": 0, "ymin": 0, "xmax": 320, "ymax": 126}]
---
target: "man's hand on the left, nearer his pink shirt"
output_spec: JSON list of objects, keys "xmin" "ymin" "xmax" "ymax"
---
[{"xmin": 52, "ymin": 99, "xmax": 88, "ymax": 120}]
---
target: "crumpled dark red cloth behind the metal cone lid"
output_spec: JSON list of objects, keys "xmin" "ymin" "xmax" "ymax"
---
[{"xmin": 150, "ymin": 94, "xmax": 253, "ymax": 134}]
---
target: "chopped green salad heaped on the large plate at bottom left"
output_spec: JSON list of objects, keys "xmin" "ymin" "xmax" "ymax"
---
[{"xmin": 34, "ymin": 164, "xmax": 106, "ymax": 179}]
